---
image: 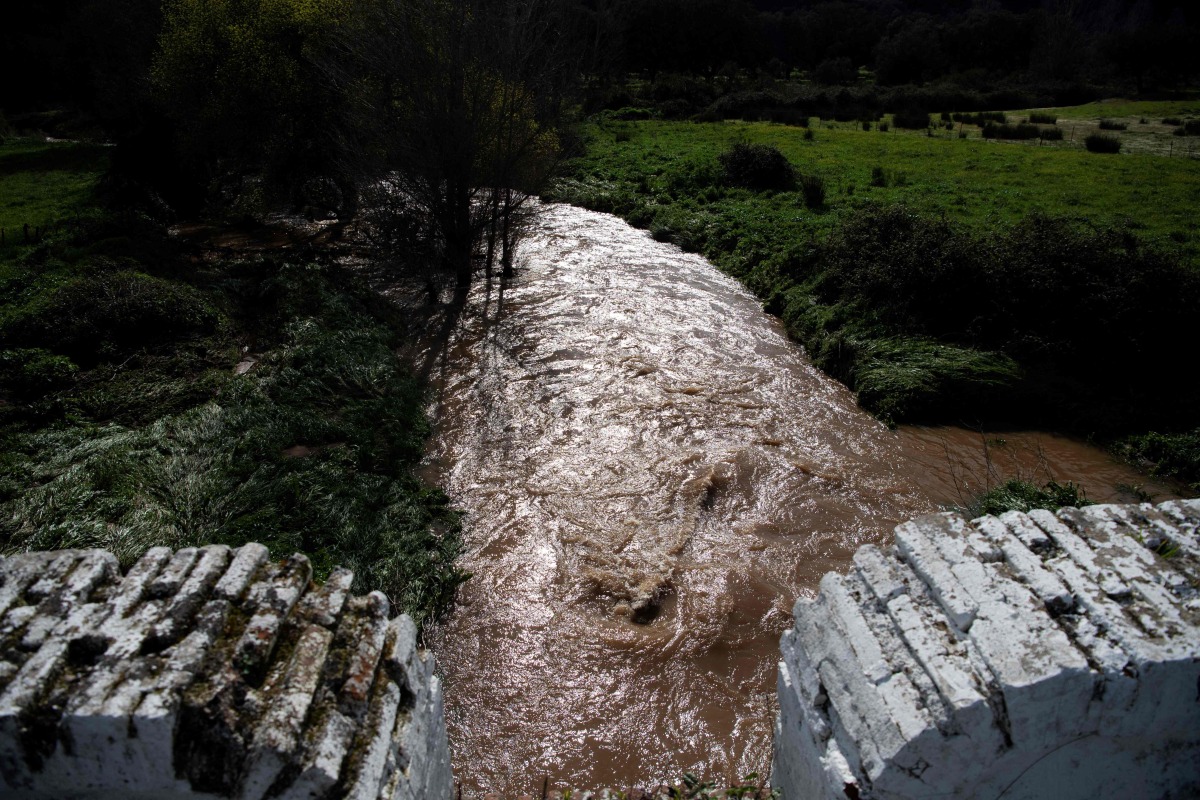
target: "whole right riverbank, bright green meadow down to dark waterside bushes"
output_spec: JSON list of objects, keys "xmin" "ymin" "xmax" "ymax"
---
[{"xmin": 556, "ymin": 106, "xmax": 1200, "ymax": 480}]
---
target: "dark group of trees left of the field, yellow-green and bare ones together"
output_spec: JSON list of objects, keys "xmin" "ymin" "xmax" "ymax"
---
[{"xmin": 2, "ymin": 0, "xmax": 584, "ymax": 293}]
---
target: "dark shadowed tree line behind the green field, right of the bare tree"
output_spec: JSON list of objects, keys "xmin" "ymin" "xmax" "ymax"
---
[{"xmin": 584, "ymin": 0, "xmax": 1200, "ymax": 91}]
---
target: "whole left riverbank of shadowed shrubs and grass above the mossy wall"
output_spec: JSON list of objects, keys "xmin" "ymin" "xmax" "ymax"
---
[{"xmin": 0, "ymin": 142, "xmax": 462, "ymax": 622}]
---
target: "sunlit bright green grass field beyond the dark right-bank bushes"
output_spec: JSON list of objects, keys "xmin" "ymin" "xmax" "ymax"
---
[{"xmin": 575, "ymin": 114, "xmax": 1200, "ymax": 260}]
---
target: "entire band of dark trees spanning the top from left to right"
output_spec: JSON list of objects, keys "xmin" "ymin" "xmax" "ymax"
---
[{"xmin": 0, "ymin": 0, "xmax": 1200, "ymax": 292}]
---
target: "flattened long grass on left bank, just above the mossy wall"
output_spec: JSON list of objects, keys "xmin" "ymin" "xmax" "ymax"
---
[{"xmin": 0, "ymin": 266, "xmax": 463, "ymax": 624}]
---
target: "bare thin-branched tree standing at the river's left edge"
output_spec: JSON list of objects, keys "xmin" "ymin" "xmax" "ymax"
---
[{"xmin": 328, "ymin": 0, "xmax": 576, "ymax": 291}]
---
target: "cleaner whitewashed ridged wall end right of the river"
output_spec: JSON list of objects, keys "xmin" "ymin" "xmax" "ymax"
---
[{"xmin": 772, "ymin": 500, "xmax": 1200, "ymax": 800}]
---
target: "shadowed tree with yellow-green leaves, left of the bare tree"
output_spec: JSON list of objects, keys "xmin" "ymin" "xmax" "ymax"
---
[{"xmin": 151, "ymin": 0, "xmax": 350, "ymax": 209}]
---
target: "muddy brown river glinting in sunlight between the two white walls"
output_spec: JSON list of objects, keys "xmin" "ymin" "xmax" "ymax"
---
[{"xmin": 417, "ymin": 206, "xmax": 1169, "ymax": 796}]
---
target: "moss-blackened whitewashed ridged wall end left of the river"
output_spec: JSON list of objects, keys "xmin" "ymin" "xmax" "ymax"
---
[{"xmin": 0, "ymin": 545, "xmax": 452, "ymax": 800}]
